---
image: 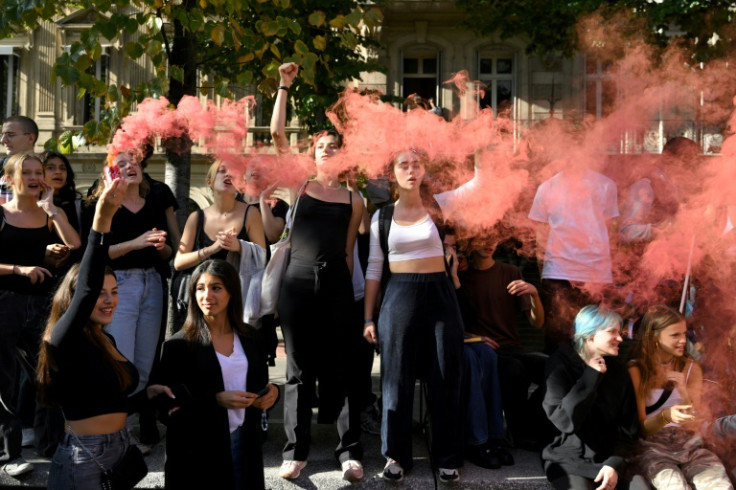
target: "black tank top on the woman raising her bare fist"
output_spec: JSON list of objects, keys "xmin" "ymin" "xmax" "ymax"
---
[{"xmin": 291, "ymin": 193, "xmax": 353, "ymax": 263}]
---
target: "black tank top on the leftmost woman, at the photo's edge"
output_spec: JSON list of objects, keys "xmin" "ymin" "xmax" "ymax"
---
[{"xmin": 0, "ymin": 214, "xmax": 56, "ymax": 295}]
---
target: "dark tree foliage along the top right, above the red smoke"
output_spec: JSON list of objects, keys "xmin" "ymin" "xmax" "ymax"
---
[{"xmin": 458, "ymin": 0, "xmax": 736, "ymax": 62}]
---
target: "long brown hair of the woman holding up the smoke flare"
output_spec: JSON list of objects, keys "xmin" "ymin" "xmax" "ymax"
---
[{"xmin": 36, "ymin": 264, "xmax": 133, "ymax": 405}]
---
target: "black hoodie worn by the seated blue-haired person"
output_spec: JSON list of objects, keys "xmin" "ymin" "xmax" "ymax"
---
[{"xmin": 542, "ymin": 344, "xmax": 639, "ymax": 479}]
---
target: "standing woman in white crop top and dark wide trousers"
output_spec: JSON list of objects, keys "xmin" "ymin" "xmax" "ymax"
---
[{"xmin": 363, "ymin": 151, "xmax": 463, "ymax": 482}]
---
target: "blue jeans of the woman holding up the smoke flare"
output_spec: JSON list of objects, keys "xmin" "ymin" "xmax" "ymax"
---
[{"xmin": 48, "ymin": 429, "xmax": 130, "ymax": 490}]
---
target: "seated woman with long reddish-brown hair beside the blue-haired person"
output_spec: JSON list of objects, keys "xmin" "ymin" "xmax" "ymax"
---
[{"xmin": 629, "ymin": 305, "xmax": 733, "ymax": 490}]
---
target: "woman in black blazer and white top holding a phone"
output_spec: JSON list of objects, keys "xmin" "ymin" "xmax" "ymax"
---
[{"xmin": 158, "ymin": 259, "xmax": 278, "ymax": 490}]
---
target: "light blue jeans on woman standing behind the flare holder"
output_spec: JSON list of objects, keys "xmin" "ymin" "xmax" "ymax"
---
[{"xmin": 105, "ymin": 268, "xmax": 164, "ymax": 393}]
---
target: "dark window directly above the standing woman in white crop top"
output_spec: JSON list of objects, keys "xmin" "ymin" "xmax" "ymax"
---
[{"xmin": 401, "ymin": 46, "xmax": 441, "ymax": 109}]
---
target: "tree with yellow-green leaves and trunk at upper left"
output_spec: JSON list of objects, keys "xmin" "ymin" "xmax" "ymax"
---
[{"xmin": 0, "ymin": 0, "xmax": 382, "ymax": 224}]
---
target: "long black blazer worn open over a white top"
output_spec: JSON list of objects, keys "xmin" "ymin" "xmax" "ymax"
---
[{"xmin": 157, "ymin": 331, "xmax": 268, "ymax": 490}]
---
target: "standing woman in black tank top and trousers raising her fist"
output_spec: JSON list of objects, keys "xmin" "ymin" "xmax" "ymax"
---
[{"xmin": 271, "ymin": 63, "xmax": 364, "ymax": 481}]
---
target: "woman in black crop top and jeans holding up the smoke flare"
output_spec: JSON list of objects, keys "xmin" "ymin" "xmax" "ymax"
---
[{"xmin": 38, "ymin": 174, "xmax": 173, "ymax": 490}]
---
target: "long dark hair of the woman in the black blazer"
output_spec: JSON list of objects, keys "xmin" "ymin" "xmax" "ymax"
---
[{"xmin": 181, "ymin": 259, "xmax": 254, "ymax": 345}]
